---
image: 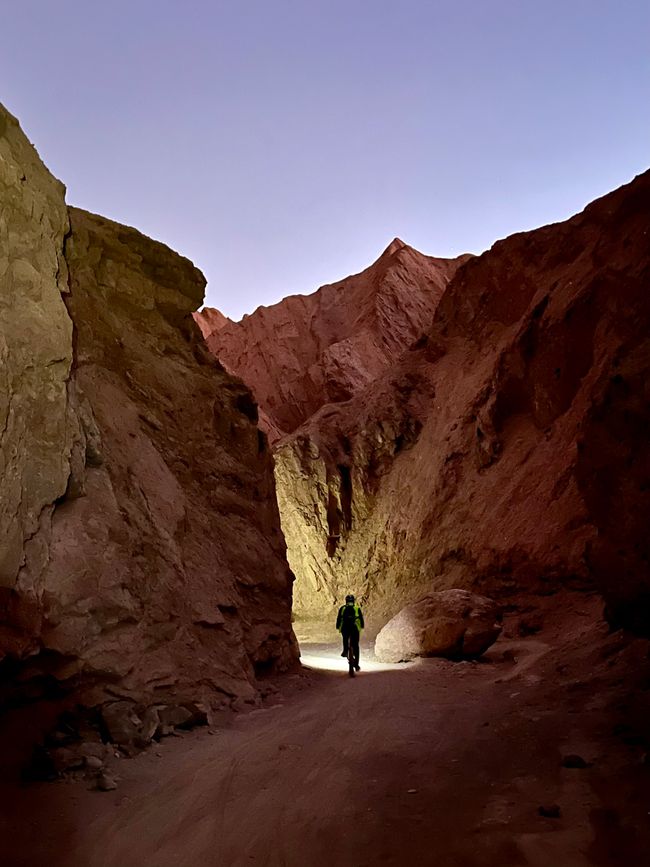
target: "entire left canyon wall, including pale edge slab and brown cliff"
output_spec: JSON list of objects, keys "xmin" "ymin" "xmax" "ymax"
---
[{"xmin": 0, "ymin": 109, "xmax": 297, "ymax": 724}]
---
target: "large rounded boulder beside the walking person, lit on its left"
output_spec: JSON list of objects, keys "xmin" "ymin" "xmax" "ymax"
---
[{"xmin": 375, "ymin": 590, "xmax": 501, "ymax": 662}]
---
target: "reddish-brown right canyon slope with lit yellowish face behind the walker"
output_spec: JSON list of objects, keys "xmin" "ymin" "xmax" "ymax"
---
[{"xmin": 276, "ymin": 173, "xmax": 650, "ymax": 630}]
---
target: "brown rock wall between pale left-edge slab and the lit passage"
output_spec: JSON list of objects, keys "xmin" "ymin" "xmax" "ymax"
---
[{"xmin": 53, "ymin": 209, "xmax": 293, "ymax": 694}]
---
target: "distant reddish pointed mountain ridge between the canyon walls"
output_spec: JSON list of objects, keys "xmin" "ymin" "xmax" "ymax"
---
[{"xmin": 199, "ymin": 238, "xmax": 468, "ymax": 442}]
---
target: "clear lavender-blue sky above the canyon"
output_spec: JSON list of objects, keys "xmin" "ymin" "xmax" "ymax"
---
[{"xmin": 0, "ymin": 0, "xmax": 650, "ymax": 318}]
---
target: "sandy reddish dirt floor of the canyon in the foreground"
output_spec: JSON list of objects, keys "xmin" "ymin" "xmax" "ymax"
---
[{"xmin": 4, "ymin": 594, "xmax": 650, "ymax": 867}]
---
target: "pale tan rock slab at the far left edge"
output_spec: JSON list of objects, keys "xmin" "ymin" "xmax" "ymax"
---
[{"xmin": 0, "ymin": 106, "xmax": 74, "ymax": 596}]
